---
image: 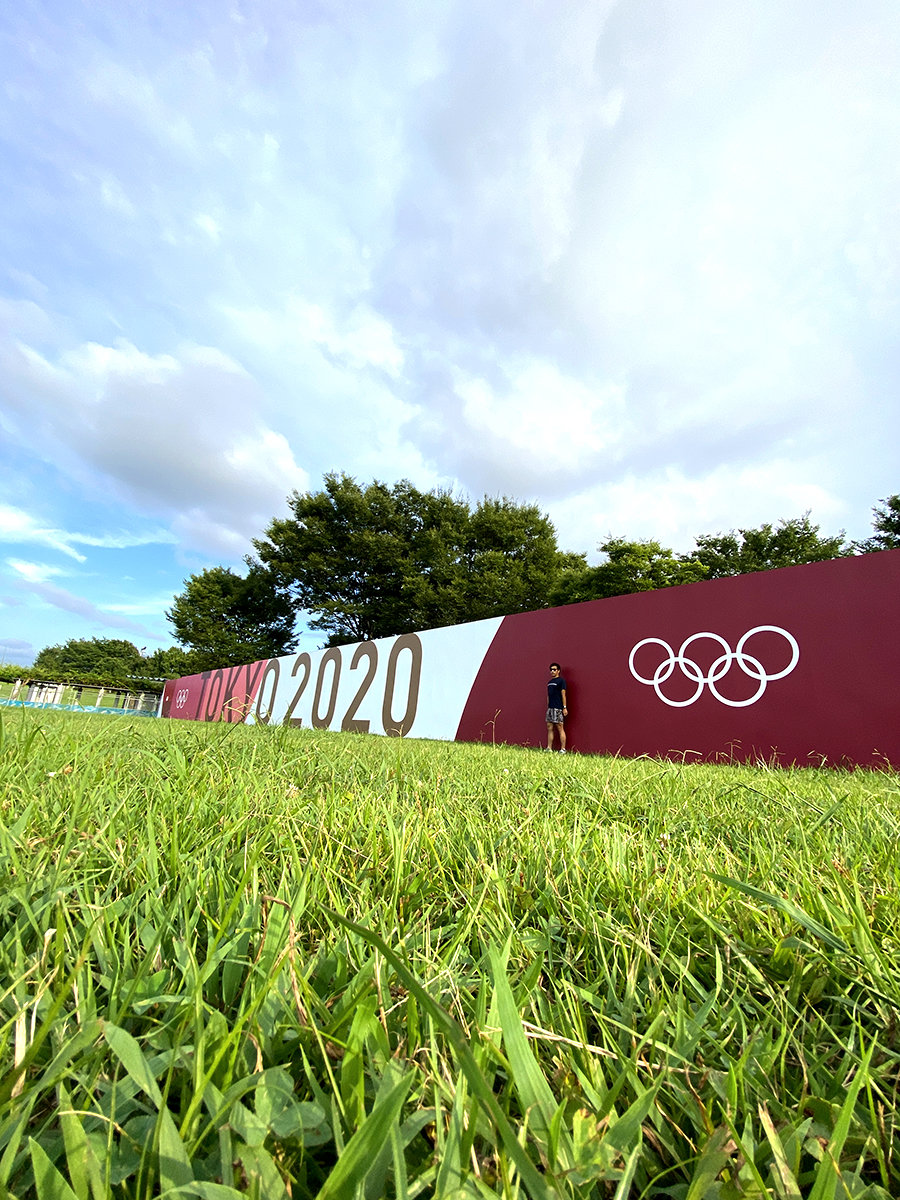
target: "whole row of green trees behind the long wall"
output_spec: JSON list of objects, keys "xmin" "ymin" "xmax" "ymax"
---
[{"xmin": 21, "ymin": 473, "xmax": 900, "ymax": 685}]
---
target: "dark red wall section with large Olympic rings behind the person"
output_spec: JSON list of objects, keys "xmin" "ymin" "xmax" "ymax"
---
[{"xmin": 457, "ymin": 551, "xmax": 900, "ymax": 766}]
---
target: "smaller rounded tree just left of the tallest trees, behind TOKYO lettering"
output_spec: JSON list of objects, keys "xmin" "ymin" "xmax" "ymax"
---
[{"xmin": 166, "ymin": 565, "xmax": 296, "ymax": 672}]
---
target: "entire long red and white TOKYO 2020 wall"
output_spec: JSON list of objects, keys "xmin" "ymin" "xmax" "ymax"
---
[{"xmin": 161, "ymin": 550, "xmax": 900, "ymax": 768}]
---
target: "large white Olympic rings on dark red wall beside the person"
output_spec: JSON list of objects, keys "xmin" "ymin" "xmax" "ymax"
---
[{"xmin": 628, "ymin": 625, "xmax": 800, "ymax": 708}]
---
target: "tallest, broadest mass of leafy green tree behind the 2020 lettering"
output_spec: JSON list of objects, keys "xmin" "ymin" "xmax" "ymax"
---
[{"xmin": 253, "ymin": 473, "xmax": 585, "ymax": 646}]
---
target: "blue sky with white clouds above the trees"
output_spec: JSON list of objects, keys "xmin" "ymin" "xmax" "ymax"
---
[{"xmin": 0, "ymin": 0, "xmax": 900, "ymax": 665}]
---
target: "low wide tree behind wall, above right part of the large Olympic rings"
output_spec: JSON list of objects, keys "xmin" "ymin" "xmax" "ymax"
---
[{"xmin": 690, "ymin": 512, "xmax": 853, "ymax": 580}]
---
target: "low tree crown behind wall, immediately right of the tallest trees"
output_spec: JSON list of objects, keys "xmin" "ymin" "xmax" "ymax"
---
[{"xmin": 552, "ymin": 538, "xmax": 707, "ymax": 605}]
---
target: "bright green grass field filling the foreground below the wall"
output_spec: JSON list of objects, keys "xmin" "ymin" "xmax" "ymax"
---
[{"xmin": 0, "ymin": 710, "xmax": 900, "ymax": 1200}]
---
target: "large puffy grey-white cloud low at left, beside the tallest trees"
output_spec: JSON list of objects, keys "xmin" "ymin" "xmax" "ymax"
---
[{"xmin": 0, "ymin": 326, "xmax": 307, "ymax": 558}]
